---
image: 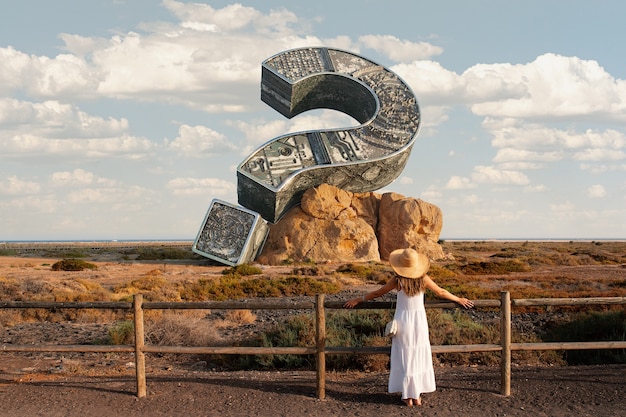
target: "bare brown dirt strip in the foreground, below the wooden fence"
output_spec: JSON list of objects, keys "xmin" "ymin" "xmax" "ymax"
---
[{"xmin": 0, "ymin": 365, "xmax": 626, "ymax": 417}]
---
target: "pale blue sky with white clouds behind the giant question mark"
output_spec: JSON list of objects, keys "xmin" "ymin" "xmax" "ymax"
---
[{"xmin": 0, "ymin": 0, "xmax": 626, "ymax": 241}]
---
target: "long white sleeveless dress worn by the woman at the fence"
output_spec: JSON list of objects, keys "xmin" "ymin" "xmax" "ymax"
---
[{"xmin": 389, "ymin": 290, "xmax": 436, "ymax": 399}]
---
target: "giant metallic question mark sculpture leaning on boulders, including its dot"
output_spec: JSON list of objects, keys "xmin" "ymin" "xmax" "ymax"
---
[{"xmin": 192, "ymin": 47, "xmax": 420, "ymax": 265}]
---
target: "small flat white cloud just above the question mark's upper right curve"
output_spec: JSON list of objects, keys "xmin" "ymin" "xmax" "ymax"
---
[{"xmin": 359, "ymin": 35, "xmax": 443, "ymax": 62}]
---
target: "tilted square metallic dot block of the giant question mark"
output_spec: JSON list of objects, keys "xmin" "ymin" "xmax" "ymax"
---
[{"xmin": 191, "ymin": 199, "xmax": 269, "ymax": 266}]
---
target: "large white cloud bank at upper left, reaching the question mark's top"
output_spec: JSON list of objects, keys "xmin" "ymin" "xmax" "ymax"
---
[{"xmin": 0, "ymin": 1, "xmax": 322, "ymax": 112}]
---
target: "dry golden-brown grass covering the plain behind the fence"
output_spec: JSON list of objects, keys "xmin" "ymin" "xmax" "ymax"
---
[{"xmin": 0, "ymin": 242, "xmax": 626, "ymax": 371}]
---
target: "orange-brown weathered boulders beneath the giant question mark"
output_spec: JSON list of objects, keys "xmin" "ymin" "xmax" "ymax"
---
[{"xmin": 256, "ymin": 184, "xmax": 444, "ymax": 265}]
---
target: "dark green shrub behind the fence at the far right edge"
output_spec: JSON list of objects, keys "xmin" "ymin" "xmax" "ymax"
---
[{"xmin": 544, "ymin": 311, "xmax": 626, "ymax": 365}]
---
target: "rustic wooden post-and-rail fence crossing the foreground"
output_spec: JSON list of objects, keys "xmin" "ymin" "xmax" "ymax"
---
[{"xmin": 0, "ymin": 292, "xmax": 626, "ymax": 399}]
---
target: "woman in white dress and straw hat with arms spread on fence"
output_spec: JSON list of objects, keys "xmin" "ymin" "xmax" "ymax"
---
[{"xmin": 344, "ymin": 248, "xmax": 474, "ymax": 407}]
